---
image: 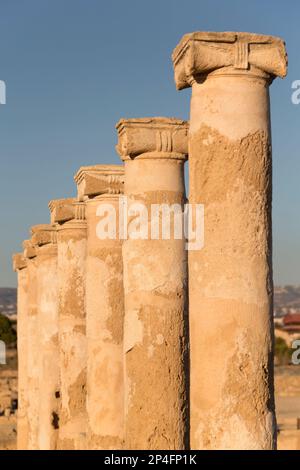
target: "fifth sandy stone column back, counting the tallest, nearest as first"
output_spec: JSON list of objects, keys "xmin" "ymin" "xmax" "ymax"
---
[{"xmin": 31, "ymin": 224, "xmax": 59, "ymax": 450}]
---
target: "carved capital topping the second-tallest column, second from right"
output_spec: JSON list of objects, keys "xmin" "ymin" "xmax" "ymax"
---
[{"xmin": 116, "ymin": 117, "xmax": 189, "ymax": 160}]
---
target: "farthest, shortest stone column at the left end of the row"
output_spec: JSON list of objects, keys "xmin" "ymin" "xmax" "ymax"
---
[{"xmin": 13, "ymin": 253, "xmax": 28, "ymax": 450}]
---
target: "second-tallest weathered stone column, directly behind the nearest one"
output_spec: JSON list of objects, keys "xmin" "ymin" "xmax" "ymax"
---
[{"xmin": 117, "ymin": 118, "xmax": 188, "ymax": 450}]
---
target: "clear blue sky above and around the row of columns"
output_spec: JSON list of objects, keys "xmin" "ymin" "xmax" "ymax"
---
[{"xmin": 0, "ymin": 0, "xmax": 300, "ymax": 287}]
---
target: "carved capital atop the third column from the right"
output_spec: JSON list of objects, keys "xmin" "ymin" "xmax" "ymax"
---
[{"xmin": 74, "ymin": 165, "xmax": 124, "ymax": 201}]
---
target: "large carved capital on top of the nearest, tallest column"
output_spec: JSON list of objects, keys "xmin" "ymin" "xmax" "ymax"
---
[{"xmin": 172, "ymin": 31, "xmax": 287, "ymax": 90}]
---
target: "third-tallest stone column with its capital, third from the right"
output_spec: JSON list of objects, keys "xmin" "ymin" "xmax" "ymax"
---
[{"xmin": 75, "ymin": 165, "xmax": 124, "ymax": 449}]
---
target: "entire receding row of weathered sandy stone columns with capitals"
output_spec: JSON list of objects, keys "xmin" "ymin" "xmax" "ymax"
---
[{"xmin": 13, "ymin": 32, "xmax": 287, "ymax": 450}]
